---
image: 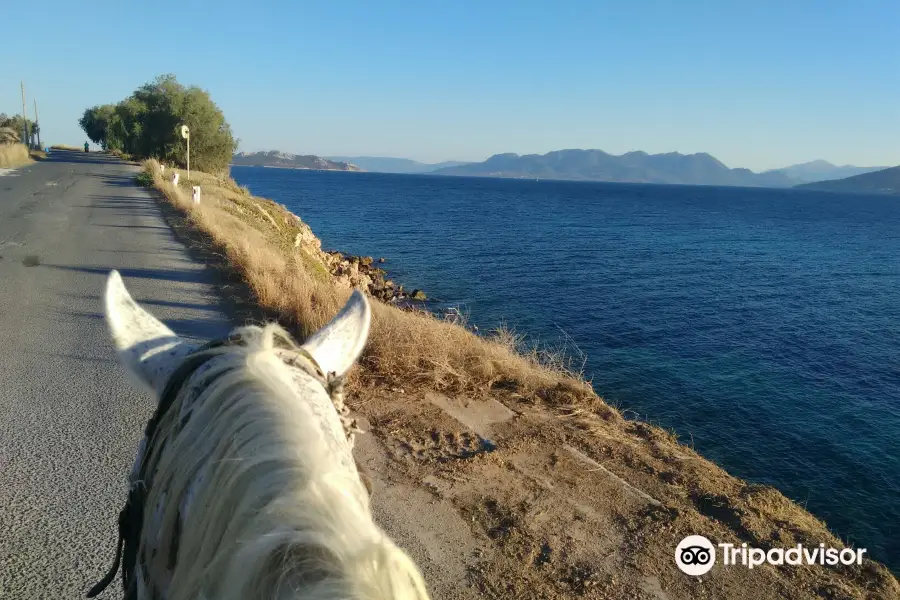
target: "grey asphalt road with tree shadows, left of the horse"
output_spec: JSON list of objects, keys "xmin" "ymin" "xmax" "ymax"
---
[{"xmin": 0, "ymin": 152, "xmax": 229, "ymax": 600}]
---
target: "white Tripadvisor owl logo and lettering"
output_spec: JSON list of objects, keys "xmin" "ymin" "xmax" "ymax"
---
[{"xmin": 675, "ymin": 535, "xmax": 866, "ymax": 577}]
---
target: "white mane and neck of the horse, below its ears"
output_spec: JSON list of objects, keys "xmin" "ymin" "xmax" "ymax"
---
[{"xmin": 138, "ymin": 325, "xmax": 428, "ymax": 600}]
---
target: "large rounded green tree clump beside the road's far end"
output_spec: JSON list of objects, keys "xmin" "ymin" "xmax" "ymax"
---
[{"xmin": 78, "ymin": 75, "xmax": 237, "ymax": 173}]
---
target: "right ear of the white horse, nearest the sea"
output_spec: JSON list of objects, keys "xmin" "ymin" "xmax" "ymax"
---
[{"xmin": 303, "ymin": 290, "xmax": 372, "ymax": 375}]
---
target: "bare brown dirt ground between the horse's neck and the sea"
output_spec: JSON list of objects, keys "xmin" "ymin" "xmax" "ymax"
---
[{"xmin": 351, "ymin": 384, "xmax": 900, "ymax": 600}]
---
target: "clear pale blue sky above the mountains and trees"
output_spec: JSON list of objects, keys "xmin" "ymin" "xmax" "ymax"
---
[{"xmin": 0, "ymin": 0, "xmax": 900, "ymax": 170}]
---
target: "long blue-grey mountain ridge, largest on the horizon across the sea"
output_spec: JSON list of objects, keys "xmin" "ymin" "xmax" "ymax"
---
[{"xmin": 434, "ymin": 150, "xmax": 793, "ymax": 187}]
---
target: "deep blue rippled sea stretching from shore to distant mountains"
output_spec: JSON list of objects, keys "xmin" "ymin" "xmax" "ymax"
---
[{"xmin": 232, "ymin": 167, "xmax": 900, "ymax": 571}]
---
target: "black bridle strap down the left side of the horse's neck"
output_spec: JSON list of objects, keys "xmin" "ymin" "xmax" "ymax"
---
[{"xmin": 87, "ymin": 336, "xmax": 242, "ymax": 599}]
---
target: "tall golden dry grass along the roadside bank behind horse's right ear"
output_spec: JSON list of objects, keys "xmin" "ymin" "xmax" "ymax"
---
[{"xmin": 144, "ymin": 160, "xmax": 598, "ymax": 404}]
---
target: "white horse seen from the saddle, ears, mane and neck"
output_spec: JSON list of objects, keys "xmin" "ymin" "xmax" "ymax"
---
[{"xmin": 89, "ymin": 271, "xmax": 428, "ymax": 600}]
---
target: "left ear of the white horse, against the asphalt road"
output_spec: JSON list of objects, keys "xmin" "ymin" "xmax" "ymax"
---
[{"xmin": 103, "ymin": 271, "xmax": 194, "ymax": 396}]
